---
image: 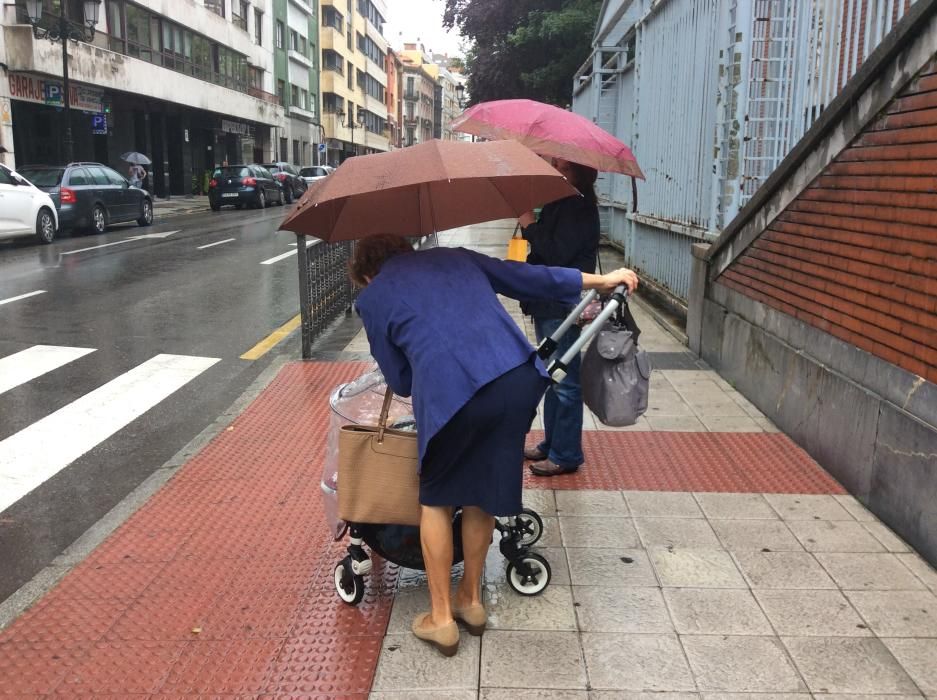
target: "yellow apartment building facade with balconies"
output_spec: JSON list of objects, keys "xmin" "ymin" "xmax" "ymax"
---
[{"xmin": 320, "ymin": 0, "xmax": 389, "ymax": 165}]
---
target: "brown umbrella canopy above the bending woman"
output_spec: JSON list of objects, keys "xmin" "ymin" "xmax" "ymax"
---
[{"xmin": 280, "ymin": 140, "xmax": 578, "ymax": 241}]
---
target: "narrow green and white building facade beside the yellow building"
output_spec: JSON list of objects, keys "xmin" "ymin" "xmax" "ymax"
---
[{"xmin": 265, "ymin": 0, "xmax": 325, "ymax": 166}]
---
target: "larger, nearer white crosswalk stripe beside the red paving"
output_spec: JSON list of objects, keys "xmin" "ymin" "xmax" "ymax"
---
[{"xmin": 0, "ymin": 355, "xmax": 220, "ymax": 512}]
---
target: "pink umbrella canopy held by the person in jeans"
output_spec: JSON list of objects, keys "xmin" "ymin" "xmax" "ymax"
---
[{"xmin": 452, "ymin": 100, "xmax": 644, "ymax": 180}]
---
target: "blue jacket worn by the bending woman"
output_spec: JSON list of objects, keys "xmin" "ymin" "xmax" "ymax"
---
[{"xmin": 357, "ymin": 248, "xmax": 582, "ymax": 459}]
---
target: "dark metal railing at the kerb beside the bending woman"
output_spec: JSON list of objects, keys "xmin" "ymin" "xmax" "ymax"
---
[{"xmin": 296, "ymin": 234, "xmax": 357, "ymax": 359}]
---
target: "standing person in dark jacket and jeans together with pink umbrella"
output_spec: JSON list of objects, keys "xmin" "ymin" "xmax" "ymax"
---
[{"xmin": 453, "ymin": 100, "xmax": 644, "ymax": 477}]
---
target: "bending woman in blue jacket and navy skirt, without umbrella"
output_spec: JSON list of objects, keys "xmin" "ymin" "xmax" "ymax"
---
[{"xmin": 350, "ymin": 236, "xmax": 637, "ymax": 656}]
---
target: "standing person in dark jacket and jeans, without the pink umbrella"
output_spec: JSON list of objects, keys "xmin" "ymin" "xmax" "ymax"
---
[{"xmin": 519, "ymin": 158, "xmax": 599, "ymax": 476}]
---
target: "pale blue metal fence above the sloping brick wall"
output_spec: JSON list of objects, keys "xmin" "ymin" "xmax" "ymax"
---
[{"xmin": 573, "ymin": 0, "xmax": 914, "ymax": 299}]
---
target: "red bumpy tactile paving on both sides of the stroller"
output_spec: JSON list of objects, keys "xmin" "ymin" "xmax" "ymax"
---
[{"xmin": 0, "ymin": 362, "xmax": 843, "ymax": 700}]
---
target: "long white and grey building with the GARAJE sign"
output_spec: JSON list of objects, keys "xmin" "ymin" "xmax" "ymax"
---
[{"xmin": 0, "ymin": 0, "xmax": 295, "ymax": 196}]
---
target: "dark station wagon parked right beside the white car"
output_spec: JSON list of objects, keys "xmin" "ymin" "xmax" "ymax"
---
[{"xmin": 17, "ymin": 162, "xmax": 153, "ymax": 233}]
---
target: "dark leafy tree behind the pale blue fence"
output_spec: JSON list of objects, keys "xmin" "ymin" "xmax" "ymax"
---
[{"xmin": 443, "ymin": 0, "xmax": 601, "ymax": 106}]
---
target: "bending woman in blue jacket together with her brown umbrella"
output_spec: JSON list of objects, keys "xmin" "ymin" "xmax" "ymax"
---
[{"xmin": 281, "ymin": 141, "xmax": 637, "ymax": 656}]
